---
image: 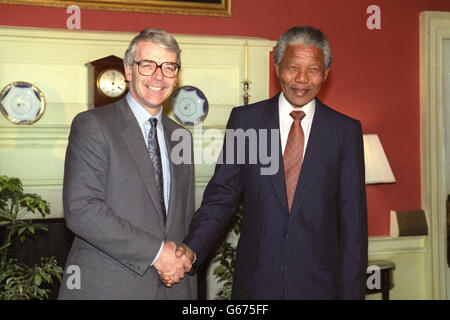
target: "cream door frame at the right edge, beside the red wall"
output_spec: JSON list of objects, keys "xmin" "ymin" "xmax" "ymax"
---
[{"xmin": 420, "ymin": 11, "xmax": 450, "ymax": 299}]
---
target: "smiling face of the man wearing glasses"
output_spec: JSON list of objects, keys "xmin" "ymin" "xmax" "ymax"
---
[{"xmin": 125, "ymin": 41, "xmax": 178, "ymax": 115}]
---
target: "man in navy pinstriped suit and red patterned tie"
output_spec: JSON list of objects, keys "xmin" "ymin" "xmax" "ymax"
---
[{"xmin": 171, "ymin": 26, "xmax": 368, "ymax": 299}]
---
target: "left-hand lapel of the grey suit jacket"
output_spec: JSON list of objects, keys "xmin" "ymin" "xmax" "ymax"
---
[{"xmin": 119, "ymin": 99, "xmax": 163, "ymax": 228}]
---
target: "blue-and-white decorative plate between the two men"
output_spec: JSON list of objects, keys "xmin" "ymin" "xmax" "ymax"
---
[{"xmin": 171, "ymin": 86, "xmax": 209, "ymax": 125}]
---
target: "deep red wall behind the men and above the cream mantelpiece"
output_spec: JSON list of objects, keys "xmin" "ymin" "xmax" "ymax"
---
[{"xmin": 0, "ymin": 0, "xmax": 450, "ymax": 236}]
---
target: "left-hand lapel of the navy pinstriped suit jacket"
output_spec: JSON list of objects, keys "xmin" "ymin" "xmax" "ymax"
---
[{"xmin": 260, "ymin": 94, "xmax": 288, "ymax": 212}]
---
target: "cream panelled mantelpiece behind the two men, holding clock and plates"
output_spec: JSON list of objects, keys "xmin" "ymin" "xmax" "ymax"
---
[{"xmin": 0, "ymin": 27, "xmax": 275, "ymax": 217}]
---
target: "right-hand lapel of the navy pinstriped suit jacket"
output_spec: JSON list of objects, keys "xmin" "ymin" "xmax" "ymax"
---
[{"xmin": 291, "ymin": 98, "xmax": 329, "ymax": 216}]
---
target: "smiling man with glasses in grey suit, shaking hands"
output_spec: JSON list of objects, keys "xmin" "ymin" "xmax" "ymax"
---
[{"xmin": 59, "ymin": 29, "xmax": 197, "ymax": 299}]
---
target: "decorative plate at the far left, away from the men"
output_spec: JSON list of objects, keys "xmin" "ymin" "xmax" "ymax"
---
[{"xmin": 0, "ymin": 81, "xmax": 45, "ymax": 124}]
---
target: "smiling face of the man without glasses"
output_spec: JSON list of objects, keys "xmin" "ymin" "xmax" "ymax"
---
[{"xmin": 275, "ymin": 44, "xmax": 329, "ymax": 108}]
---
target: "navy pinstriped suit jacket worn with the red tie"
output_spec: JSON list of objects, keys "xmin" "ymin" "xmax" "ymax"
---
[{"xmin": 185, "ymin": 95, "xmax": 368, "ymax": 299}]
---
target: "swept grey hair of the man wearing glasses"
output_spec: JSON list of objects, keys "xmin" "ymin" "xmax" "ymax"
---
[{"xmin": 123, "ymin": 28, "xmax": 181, "ymax": 66}]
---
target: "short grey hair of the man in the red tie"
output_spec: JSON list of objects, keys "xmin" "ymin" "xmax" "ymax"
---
[{"xmin": 273, "ymin": 26, "xmax": 333, "ymax": 69}]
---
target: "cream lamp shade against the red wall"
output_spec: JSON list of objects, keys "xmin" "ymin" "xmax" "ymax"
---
[{"xmin": 363, "ymin": 134, "xmax": 395, "ymax": 184}]
